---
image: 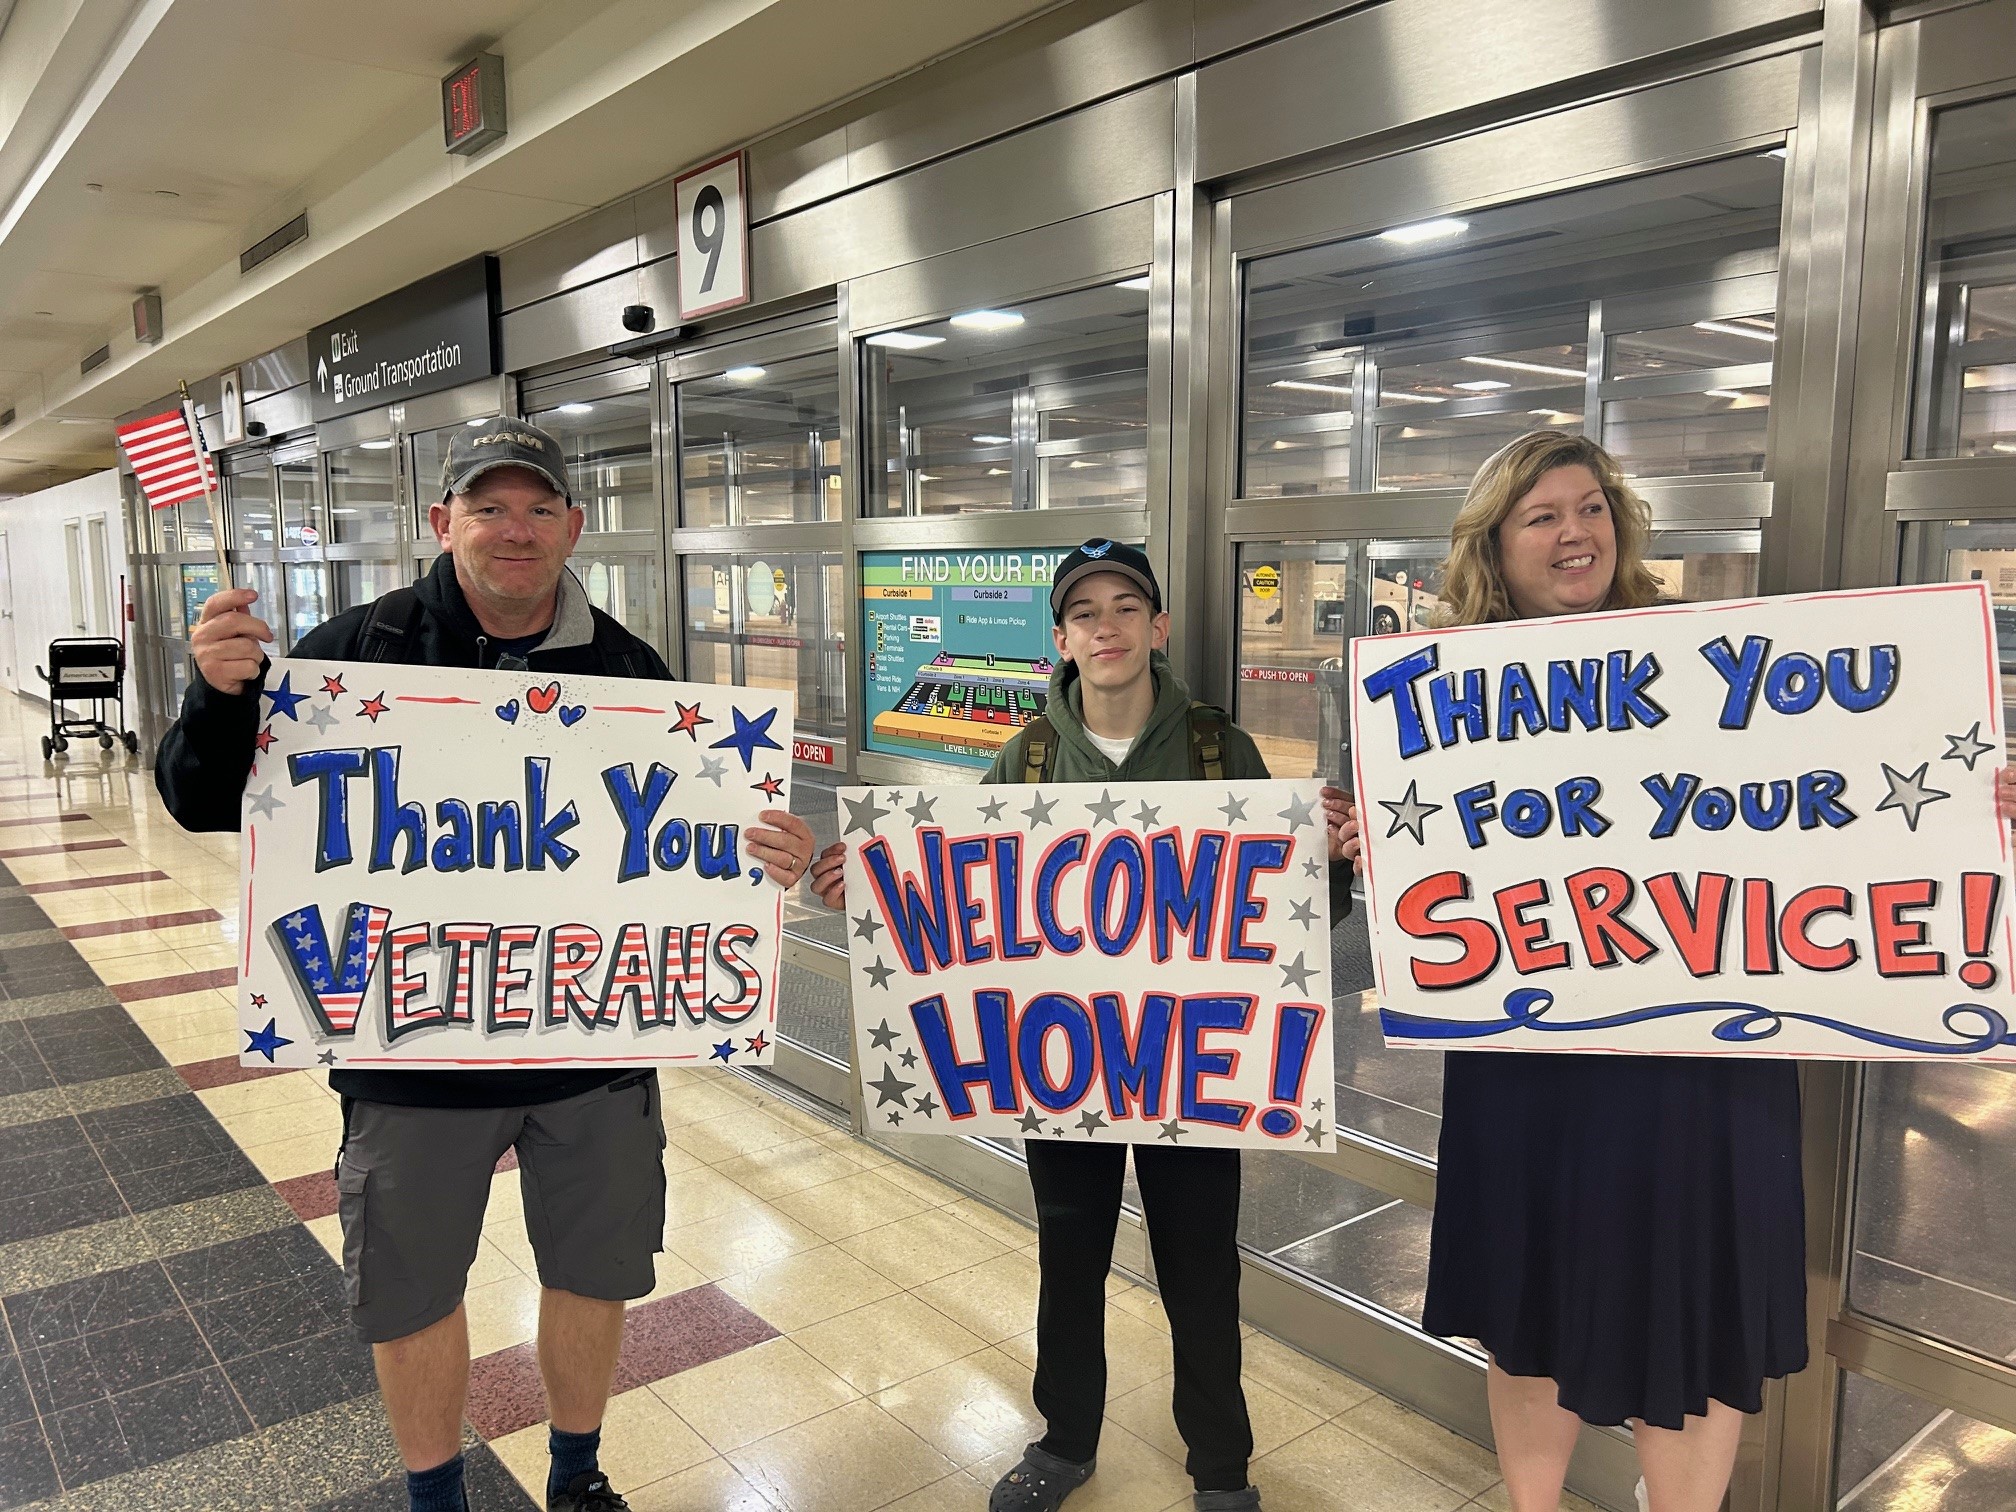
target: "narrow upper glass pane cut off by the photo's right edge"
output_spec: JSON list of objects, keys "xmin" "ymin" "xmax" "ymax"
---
[{"xmin": 1913, "ymin": 95, "xmax": 2016, "ymax": 458}]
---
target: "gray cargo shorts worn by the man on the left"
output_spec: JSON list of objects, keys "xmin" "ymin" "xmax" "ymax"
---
[{"xmin": 337, "ymin": 1073, "xmax": 665, "ymax": 1345}]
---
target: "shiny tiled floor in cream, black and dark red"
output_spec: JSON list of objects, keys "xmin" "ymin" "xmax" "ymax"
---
[{"xmin": 0, "ymin": 696, "xmax": 1556, "ymax": 1512}]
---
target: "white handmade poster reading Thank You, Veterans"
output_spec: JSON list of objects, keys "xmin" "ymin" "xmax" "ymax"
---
[{"xmin": 238, "ymin": 661, "xmax": 792, "ymax": 1068}]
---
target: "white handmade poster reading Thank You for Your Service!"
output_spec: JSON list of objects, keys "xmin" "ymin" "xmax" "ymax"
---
[{"xmin": 1351, "ymin": 583, "xmax": 2016, "ymax": 1060}]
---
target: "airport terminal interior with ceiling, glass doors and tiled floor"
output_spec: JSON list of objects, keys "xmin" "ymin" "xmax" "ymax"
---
[{"xmin": 0, "ymin": 0, "xmax": 2016, "ymax": 1512}]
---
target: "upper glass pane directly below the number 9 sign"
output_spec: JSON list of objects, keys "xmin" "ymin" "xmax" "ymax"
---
[{"xmin": 675, "ymin": 353, "xmax": 841, "ymax": 524}]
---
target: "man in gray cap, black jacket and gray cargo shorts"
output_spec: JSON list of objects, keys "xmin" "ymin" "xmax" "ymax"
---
[{"xmin": 155, "ymin": 417, "xmax": 812, "ymax": 1512}]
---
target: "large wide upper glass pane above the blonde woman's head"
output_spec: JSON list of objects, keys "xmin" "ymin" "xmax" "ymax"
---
[{"xmin": 1240, "ymin": 155, "xmax": 1784, "ymax": 498}]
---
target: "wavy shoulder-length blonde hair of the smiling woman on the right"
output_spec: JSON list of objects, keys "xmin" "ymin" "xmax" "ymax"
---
[{"xmin": 1435, "ymin": 431, "xmax": 1661, "ymax": 627}]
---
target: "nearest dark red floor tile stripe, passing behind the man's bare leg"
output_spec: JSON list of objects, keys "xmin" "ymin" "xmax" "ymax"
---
[{"xmin": 468, "ymin": 1286, "xmax": 776, "ymax": 1439}]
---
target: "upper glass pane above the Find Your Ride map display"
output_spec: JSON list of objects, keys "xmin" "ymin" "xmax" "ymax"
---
[{"xmin": 861, "ymin": 278, "xmax": 1147, "ymax": 514}]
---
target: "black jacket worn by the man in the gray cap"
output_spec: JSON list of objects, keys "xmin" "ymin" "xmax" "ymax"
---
[{"xmin": 153, "ymin": 552, "xmax": 671, "ymax": 1107}]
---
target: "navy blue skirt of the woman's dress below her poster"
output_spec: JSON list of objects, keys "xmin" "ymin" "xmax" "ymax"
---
[{"xmin": 1423, "ymin": 1050, "xmax": 1806, "ymax": 1429}]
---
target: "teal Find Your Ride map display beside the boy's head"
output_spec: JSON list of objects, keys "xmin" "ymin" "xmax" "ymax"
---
[{"xmin": 861, "ymin": 550, "xmax": 1064, "ymax": 766}]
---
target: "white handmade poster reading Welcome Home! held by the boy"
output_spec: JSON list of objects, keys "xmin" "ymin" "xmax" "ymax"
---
[{"xmin": 841, "ymin": 782, "xmax": 1335, "ymax": 1149}]
